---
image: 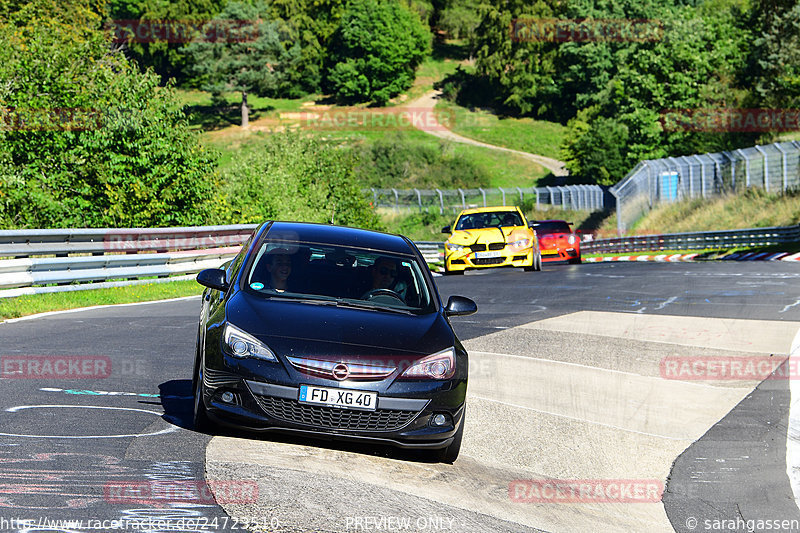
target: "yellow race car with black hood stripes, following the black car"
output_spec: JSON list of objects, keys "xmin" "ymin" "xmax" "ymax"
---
[{"xmin": 442, "ymin": 206, "xmax": 542, "ymax": 274}]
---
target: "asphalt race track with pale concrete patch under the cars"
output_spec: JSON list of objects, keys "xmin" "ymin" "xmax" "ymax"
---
[{"xmin": 0, "ymin": 262, "xmax": 800, "ymax": 533}]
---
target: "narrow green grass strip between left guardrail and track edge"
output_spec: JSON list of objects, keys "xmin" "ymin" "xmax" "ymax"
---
[{"xmin": 0, "ymin": 280, "xmax": 203, "ymax": 320}]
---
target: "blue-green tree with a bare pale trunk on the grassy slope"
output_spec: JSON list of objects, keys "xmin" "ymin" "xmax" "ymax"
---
[{"xmin": 185, "ymin": 2, "xmax": 301, "ymax": 127}]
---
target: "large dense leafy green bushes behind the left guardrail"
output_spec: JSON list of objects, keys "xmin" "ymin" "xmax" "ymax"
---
[{"xmin": 0, "ymin": 1, "xmax": 215, "ymax": 228}]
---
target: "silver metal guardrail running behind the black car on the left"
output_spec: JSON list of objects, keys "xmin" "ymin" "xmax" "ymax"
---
[{"xmin": 0, "ymin": 224, "xmax": 444, "ymax": 298}]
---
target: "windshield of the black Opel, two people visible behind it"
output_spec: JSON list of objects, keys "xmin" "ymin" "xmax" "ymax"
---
[{"xmin": 245, "ymin": 239, "xmax": 435, "ymax": 313}]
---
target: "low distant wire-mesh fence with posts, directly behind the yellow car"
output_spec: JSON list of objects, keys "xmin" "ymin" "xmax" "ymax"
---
[{"xmin": 364, "ymin": 185, "xmax": 606, "ymax": 214}]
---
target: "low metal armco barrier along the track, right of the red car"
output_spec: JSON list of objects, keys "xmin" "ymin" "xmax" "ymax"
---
[{"xmin": 581, "ymin": 225, "xmax": 800, "ymax": 253}]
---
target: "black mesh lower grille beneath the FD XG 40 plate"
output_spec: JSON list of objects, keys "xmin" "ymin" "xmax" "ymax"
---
[{"xmin": 256, "ymin": 395, "xmax": 417, "ymax": 431}]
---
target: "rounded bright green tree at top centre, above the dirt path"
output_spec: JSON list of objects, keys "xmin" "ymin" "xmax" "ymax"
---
[{"xmin": 326, "ymin": 0, "xmax": 431, "ymax": 105}]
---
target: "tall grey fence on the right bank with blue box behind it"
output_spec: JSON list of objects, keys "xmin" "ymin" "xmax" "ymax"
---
[{"xmin": 610, "ymin": 141, "xmax": 800, "ymax": 235}]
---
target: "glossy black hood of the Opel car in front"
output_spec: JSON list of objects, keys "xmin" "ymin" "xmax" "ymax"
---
[{"xmin": 227, "ymin": 292, "xmax": 455, "ymax": 358}]
